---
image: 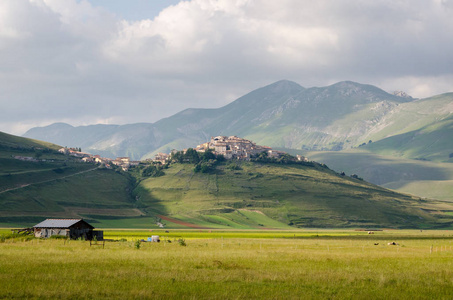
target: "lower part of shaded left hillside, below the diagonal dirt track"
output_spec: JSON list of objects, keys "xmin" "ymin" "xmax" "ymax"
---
[{"xmin": 0, "ymin": 169, "xmax": 142, "ymax": 227}]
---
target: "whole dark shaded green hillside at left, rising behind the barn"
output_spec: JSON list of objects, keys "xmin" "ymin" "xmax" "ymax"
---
[{"xmin": 0, "ymin": 133, "xmax": 142, "ymax": 227}]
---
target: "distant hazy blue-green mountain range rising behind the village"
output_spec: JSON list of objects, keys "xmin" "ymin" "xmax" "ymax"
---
[{"xmin": 24, "ymin": 80, "xmax": 453, "ymax": 159}]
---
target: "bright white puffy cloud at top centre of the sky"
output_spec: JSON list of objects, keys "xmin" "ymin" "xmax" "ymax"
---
[{"xmin": 104, "ymin": 0, "xmax": 338, "ymax": 73}]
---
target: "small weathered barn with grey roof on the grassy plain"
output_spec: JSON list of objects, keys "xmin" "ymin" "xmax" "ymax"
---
[{"xmin": 33, "ymin": 219, "xmax": 104, "ymax": 241}]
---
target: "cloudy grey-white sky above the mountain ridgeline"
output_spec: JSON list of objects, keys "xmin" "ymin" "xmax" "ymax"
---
[{"xmin": 0, "ymin": 0, "xmax": 453, "ymax": 135}]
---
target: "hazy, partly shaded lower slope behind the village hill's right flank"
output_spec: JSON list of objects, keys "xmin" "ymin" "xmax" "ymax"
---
[{"xmin": 308, "ymin": 150, "xmax": 453, "ymax": 202}]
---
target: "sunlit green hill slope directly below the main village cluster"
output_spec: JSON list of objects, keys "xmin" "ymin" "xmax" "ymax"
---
[{"xmin": 135, "ymin": 162, "xmax": 451, "ymax": 228}]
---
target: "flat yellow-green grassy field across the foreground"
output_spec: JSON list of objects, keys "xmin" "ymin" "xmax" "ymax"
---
[{"xmin": 0, "ymin": 230, "xmax": 453, "ymax": 299}]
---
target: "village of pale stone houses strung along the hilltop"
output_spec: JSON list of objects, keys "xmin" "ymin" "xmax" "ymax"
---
[{"xmin": 52, "ymin": 136, "xmax": 308, "ymax": 171}]
